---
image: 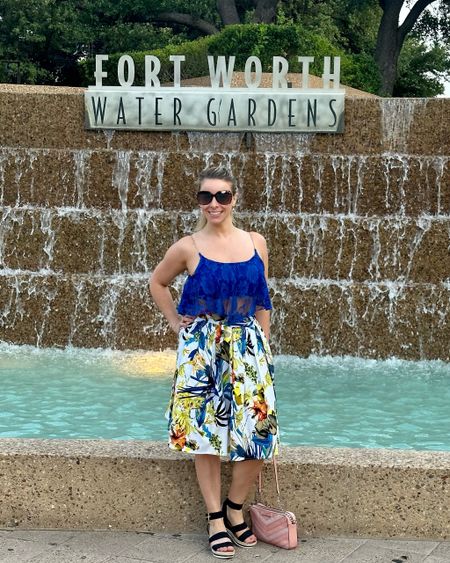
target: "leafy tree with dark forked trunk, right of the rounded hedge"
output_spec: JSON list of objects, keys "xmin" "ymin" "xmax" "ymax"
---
[{"xmin": 279, "ymin": 0, "xmax": 450, "ymax": 96}]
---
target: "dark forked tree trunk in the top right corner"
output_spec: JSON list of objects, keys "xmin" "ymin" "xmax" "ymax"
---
[{"xmin": 375, "ymin": 0, "xmax": 450, "ymax": 96}]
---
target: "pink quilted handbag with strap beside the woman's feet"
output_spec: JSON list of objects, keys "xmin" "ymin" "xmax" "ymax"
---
[{"xmin": 249, "ymin": 459, "xmax": 297, "ymax": 549}]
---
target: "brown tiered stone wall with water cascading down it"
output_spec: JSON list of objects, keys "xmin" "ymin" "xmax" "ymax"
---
[{"xmin": 0, "ymin": 86, "xmax": 450, "ymax": 360}]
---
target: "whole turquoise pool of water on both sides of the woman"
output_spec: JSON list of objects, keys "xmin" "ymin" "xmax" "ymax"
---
[{"xmin": 0, "ymin": 344, "xmax": 450, "ymax": 450}]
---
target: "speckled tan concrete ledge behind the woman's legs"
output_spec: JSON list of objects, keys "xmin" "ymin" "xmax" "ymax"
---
[{"xmin": 0, "ymin": 439, "xmax": 450, "ymax": 539}]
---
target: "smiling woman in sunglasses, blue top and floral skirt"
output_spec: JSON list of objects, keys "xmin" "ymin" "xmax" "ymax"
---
[{"xmin": 150, "ymin": 167, "xmax": 278, "ymax": 559}]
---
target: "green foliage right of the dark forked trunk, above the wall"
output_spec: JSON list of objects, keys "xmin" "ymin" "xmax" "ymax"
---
[{"xmin": 394, "ymin": 38, "xmax": 450, "ymax": 98}]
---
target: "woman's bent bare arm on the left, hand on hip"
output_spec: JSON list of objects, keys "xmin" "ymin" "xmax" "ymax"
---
[{"xmin": 150, "ymin": 239, "xmax": 188, "ymax": 334}]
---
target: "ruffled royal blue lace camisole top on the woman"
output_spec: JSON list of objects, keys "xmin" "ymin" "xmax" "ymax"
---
[{"xmin": 177, "ymin": 241, "xmax": 272, "ymax": 323}]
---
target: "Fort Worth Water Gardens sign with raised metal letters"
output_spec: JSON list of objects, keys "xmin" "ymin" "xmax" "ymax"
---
[{"xmin": 85, "ymin": 55, "xmax": 345, "ymax": 133}]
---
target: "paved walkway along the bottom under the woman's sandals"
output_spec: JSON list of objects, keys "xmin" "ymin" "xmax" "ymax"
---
[{"xmin": 0, "ymin": 530, "xmax": 450, "ymax": 563}]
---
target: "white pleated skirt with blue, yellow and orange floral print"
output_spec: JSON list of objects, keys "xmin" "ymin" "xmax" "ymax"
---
[{"xmin": 166, "ymin": 316, "xmax": 279, "ymax": 461}]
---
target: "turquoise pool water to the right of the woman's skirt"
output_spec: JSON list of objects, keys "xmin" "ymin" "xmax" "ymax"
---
[{"xmin": 277, "ymin": 356, "xmax": 450, "ymax": 450}]
